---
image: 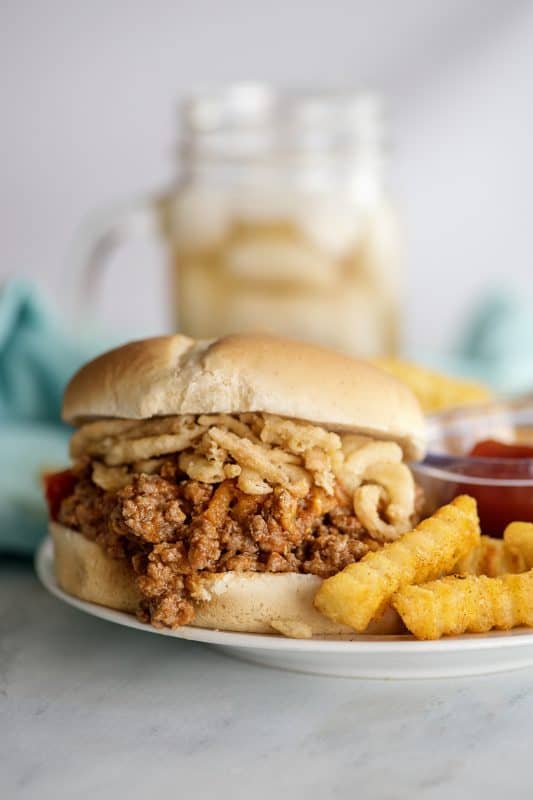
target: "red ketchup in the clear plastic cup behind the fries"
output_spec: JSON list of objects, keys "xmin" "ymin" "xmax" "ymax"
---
[{"xmin": 460, "ymin": 439, "xmax": 533, "ymax": 537}]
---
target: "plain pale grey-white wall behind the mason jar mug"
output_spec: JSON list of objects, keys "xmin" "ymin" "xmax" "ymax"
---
[{"xmin": 0, "ymin": 0, "xmax": 533, "ymax": 348}]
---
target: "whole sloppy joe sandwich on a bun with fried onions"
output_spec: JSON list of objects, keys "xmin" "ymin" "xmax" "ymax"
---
[{"xmin": 47, "ymin": 335, "xmax": 425, "ymax": 636}]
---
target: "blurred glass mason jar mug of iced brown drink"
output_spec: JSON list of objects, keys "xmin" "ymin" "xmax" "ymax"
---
[{"xmin": 80, "ymin": 85, "xmax": 402, "ymax": 356}]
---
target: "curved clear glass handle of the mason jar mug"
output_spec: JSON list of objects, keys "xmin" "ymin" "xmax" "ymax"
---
[{"xmin": 71, "ymin": 195, "xmax": 168, "ymax": 313}]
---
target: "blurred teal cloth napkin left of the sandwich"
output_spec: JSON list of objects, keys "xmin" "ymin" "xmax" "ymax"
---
[{"xmin": 0, "ymin": 281, "xmax": 113, "ymax": 555}]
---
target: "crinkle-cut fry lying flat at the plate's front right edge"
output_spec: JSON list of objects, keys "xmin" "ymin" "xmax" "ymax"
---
[{"xmin": 392, "ymin": 570, "xmax": 533, "ymax": 639}]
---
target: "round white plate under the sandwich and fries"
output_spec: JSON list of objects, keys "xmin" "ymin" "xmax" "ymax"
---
[{"xmin": 35, "ymin": 539, "xmax": 533, "ymax": 678}]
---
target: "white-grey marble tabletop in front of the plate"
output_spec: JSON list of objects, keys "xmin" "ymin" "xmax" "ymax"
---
[{"xmin": 0, "ymin": 562, "xmax": 533, "ymax": 800}]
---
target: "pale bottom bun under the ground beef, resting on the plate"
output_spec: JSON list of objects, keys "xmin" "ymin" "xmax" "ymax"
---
[{"xmin": 50, "ymin": 522, "xmax": 405, "ymax": 636}]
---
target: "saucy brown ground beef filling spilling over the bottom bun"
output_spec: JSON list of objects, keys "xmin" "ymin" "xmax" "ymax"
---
[{"xmin": 57, "ymin": 459, "xmax": 420, "ymax": 628}]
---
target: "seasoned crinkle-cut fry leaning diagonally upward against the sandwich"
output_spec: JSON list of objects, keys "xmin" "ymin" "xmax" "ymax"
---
[{"xmin": 315, "ymin": 495, "xmax": 480, "ymax": 633}]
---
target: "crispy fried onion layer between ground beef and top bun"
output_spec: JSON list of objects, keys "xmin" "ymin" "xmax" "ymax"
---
[{"xmin": 71, "ymin": 414, "xmax": 415, "ymax": 542}]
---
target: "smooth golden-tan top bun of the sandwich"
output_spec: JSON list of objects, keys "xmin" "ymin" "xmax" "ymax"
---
[{"xmin": 63, "ymin": 334, "xmax": 425, "ymax": 459}]
